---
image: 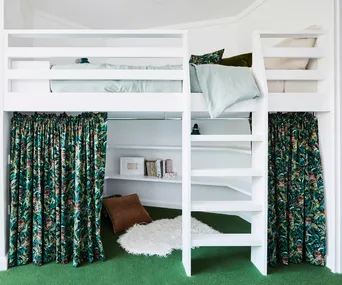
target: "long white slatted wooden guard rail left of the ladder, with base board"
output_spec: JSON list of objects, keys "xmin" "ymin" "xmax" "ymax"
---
[{"xmin": 4, "ymin": 30, "xmax": 189, "ymax": 112}]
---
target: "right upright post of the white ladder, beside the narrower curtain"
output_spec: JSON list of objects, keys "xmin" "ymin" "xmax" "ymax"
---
[{"xmin": 251, "ymin": 33, "xmax": 268, "ymax": 275}]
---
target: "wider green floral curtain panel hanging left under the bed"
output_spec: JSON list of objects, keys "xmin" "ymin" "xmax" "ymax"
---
[{"xmin": 9, "ymin": 113, "xmax": 107, "ymax": 266}]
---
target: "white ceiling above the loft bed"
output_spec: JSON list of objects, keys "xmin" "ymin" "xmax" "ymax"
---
[{"xmin": 30, "ymin": 0, "xmax": 255, "ymax": 29}]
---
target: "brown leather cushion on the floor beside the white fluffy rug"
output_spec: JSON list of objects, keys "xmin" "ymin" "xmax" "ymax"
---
[{"xmin": 103, "ymin": 194, "xmax": 152, "ymax": 233}]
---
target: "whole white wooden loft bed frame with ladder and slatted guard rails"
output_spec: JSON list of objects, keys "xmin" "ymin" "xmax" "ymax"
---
[{"xmin": 1, "ymin": 30, "xmax": 335, "ymax": 276}]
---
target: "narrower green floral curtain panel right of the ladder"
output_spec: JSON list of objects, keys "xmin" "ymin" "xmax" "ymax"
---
[{"xmin": 268, "ymin": 113, "xmax": 326, "ymax": 265}]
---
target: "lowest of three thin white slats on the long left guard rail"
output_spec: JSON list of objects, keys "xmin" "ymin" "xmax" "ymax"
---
[{"xmin": 6, "ymin": 69, "xmax": 183, "ymax": 80}]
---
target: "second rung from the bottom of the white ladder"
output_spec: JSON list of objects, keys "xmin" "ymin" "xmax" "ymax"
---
[{"xmin": 191, "ymin": 201, "xmax": 263, "ymax": 212}]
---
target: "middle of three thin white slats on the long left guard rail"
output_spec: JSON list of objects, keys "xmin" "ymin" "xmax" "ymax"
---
[{"xmin": 7, "ymin": 47, "xmax": 183, "ymax": 58}]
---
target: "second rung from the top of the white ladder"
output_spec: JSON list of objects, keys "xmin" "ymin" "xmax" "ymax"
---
[{"xmin": 191, "ymin": 168, "xmax": 263, "ymax": 177}]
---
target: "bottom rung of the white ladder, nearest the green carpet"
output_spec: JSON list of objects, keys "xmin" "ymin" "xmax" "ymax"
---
[{"xmin": 192, "ymin": 234, "xmax": 262, "ymax": 247}]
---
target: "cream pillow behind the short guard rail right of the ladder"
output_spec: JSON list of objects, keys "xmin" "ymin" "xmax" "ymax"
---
[{"xmin": 265, "ymin": 26, "xmax": 319, "ymax": 70}]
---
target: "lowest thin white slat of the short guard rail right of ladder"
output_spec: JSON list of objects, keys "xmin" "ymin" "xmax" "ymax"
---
[{"xmin": 266, "ymin": 70, "xmax": 326, "ymax": 81}]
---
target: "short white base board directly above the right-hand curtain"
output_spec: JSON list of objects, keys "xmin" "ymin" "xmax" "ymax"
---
[{"xmin": 268, "ymin": 93, "xmax": 331, "ymax": 112}]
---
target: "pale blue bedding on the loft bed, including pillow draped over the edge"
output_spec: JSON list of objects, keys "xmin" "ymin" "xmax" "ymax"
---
[{"xmin": 50, "ymin": 64, "xmax": 260, "ymax": 118}]
